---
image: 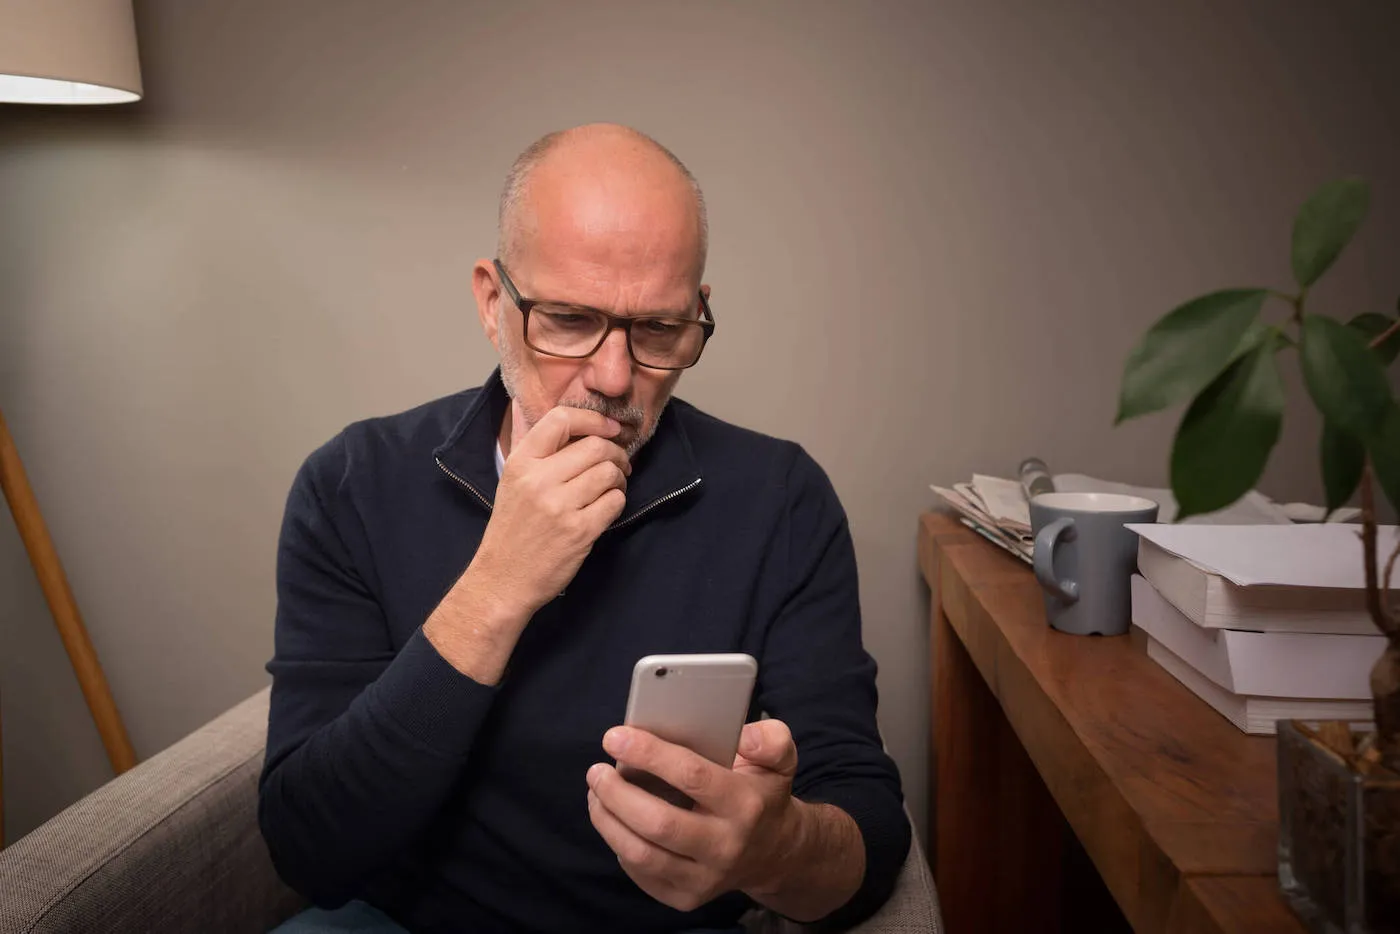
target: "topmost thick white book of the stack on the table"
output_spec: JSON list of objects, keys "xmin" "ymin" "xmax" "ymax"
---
[{"xmin": 1128, "ymin": 522, "xmax": 1400, "ymax": 636}]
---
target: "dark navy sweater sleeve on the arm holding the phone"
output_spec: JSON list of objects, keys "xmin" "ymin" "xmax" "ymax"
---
[{"xmin": 757, "ymin": 451, "xmax": 910, "ymax": 928}]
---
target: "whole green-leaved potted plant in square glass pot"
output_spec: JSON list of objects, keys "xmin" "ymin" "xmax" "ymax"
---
[{"xmin": 1116, "ymin": 178, "xmax": 1400, "ymax": 934}]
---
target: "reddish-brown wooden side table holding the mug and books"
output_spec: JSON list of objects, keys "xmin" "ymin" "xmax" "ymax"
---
[{"xmin": 918, "ymin": 513, "xmax": 1305, "ymax": 934}]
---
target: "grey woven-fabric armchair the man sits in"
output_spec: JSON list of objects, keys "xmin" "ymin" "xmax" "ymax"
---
[{"xmin": 0, "ymin": 689, "xmax": 942, "ymax": 934}]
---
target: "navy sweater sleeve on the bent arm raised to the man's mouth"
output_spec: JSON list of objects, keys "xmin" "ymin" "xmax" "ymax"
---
[{"xmin": 258, "ymin": 435, "xmax": 494, "ymax": 907}]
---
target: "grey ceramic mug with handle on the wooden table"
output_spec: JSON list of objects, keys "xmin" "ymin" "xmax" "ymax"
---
[{"xmin": 1030, "ymin": 493, "xmax": 1158, "ymax": 636}]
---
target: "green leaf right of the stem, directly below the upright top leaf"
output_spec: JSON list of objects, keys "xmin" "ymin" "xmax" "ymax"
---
[{"xmin": 1299, "ymin": 315, "xmax": 1393, "ymax": 441}]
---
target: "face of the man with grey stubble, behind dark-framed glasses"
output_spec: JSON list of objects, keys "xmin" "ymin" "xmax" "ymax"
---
[{"xmin": 473, "ymin": 149, "xmax": 711, "ymax": 456}]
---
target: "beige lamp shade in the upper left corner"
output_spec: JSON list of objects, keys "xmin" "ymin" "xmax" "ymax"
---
[{"xmin": 0, "ymin": 0, "xmax": 141, "ymax": 104}]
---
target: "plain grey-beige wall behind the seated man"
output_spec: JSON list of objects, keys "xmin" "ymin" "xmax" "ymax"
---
[{"xmin": 0, "ymin": 0, "xmax": 1400, "ymax": 839}]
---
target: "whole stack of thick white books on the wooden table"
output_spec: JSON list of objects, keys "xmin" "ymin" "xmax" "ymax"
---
[{"xmin": 1128, "ymin": 524, "xmax": 1400, "ymax": 734}]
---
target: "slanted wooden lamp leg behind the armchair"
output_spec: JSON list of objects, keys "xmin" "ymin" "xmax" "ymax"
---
[{"xmin": 0, "ymin": 412, "xmax": 136, "ymax": 795}]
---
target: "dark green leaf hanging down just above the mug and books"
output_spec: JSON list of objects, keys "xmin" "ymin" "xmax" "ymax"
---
[{"xmin": 1172, "ymin": 340, "xmax": 1284, "ymax": 521}]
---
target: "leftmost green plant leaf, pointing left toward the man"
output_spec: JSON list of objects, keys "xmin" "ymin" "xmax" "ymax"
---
[{"xmin": 1114, "ymin": 288, "xmax": 1268, "ymax": 424}]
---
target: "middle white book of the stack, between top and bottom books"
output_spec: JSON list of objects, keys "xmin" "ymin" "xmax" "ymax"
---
[{"xmin": 1133, "ymin": 574, "xmax": 1386, "ymax": 700}]
